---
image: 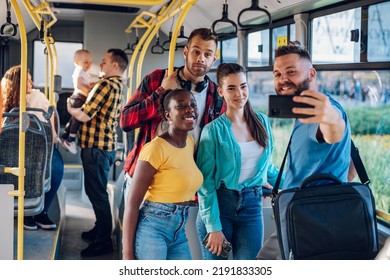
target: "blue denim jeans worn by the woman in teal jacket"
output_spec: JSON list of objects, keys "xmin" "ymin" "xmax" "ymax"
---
[{"xmin": 196, "ymin": 186, "xmax": 264, "ymax": 260}]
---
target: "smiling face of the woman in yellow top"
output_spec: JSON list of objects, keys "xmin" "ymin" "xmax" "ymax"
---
[{"xmin": 165, "ymin": 90, "xmax": 198, "ymax": 131}]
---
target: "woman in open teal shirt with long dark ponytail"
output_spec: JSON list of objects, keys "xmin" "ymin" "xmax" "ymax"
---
[{"xmin": 197, "ymin": 63, "xmax": 279, "ymax": 260}]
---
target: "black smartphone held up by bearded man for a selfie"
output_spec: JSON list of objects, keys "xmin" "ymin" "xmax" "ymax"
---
[{"xmin": 268, "ymin": 95, "xmax": 313, "ymax": 118}]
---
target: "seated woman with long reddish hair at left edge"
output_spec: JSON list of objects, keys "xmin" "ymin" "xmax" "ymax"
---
[{"xmin": 1, "ymin": 65, "xmax": 64, "ymax": 230}]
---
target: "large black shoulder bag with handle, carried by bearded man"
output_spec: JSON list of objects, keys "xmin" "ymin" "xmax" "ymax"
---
[{"xmin": 273, "ymin": 174, "xmax": 378, "ymax": 260}]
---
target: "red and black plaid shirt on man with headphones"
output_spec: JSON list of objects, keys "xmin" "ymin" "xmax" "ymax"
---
[{"xmin": 120, "ymin": 69, "xmax": 226, "ymax": 176}]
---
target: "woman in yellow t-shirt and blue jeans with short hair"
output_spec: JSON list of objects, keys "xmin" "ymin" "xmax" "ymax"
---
[{"xmin": 122, "ymin": 89, "xmax": 203, "ymax": 260}]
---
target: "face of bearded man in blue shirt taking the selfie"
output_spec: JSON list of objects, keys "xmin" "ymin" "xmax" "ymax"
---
[{"xmin": 273, "ymin": 54, "xmax": 315, "ymax": 95}]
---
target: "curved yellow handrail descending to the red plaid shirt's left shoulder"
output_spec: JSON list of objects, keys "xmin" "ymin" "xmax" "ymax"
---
[{"xmin": 136, "ymin": 0, "xmax": 182, "ymax": 85}]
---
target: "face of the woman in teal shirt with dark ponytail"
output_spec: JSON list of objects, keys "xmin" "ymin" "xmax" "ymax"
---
[{"xmin": 218, "ymin": 72, "xmax": 249, "ymax": 110}]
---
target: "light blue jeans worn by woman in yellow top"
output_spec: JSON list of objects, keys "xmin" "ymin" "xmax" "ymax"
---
[{"xmin": 135, "ymin": 200, "xmax": 191, "ymax": 260}]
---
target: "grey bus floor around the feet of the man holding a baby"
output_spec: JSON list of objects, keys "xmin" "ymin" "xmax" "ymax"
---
[{"xmin": 14, "ymin": 185, "xmax": 118, "ymax": 260}]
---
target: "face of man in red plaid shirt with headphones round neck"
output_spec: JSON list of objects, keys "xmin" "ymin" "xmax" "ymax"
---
[{"xmin": 183, "ymin": 36, "xmax": 217, "ymax": 80}]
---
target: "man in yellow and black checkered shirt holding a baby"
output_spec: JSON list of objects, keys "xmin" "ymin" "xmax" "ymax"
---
[{"xmin": 67, "ymin": 49, "xmax": 128, "ymax": 257}]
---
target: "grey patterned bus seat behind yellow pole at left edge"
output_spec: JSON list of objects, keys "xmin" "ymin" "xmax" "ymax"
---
[{"xmin": 0, "ymin": 113, "xmax": 47, "ymax": 216}]
